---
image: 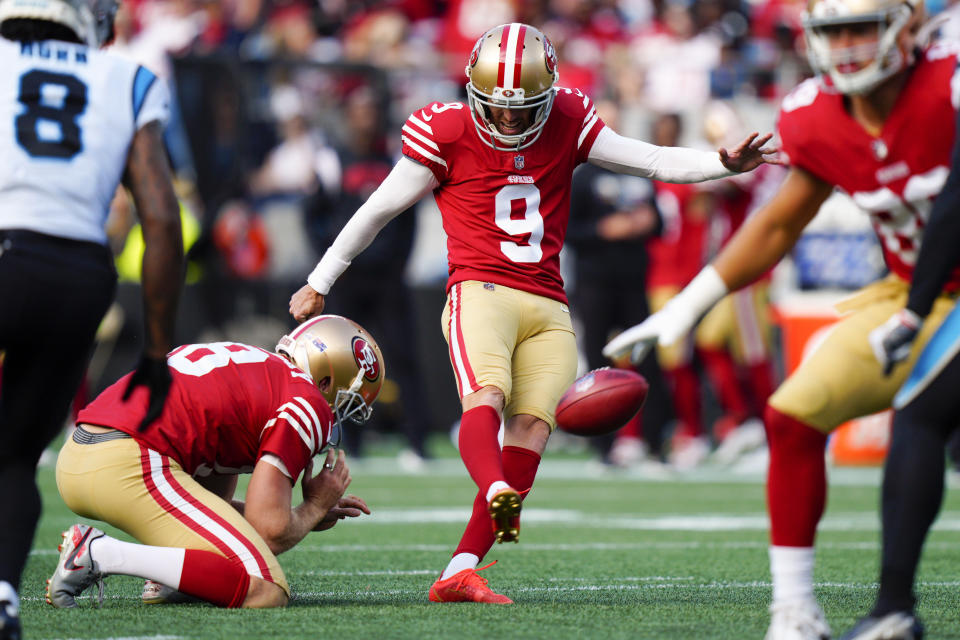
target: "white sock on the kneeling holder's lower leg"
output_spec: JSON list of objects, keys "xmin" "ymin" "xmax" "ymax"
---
[{"xmin": 90, "ymin": 536, "xmax": 185, "ymax": 589}]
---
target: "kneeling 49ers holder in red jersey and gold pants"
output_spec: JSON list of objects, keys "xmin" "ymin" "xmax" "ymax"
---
[{"xmin": 47, "ymin": 316, "xmax": 384, "ymax": 608}]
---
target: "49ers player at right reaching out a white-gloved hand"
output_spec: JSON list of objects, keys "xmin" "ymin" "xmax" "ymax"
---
[{"xmin": 606, "ymin": 0, "xmax": 960, "ymax": 640}]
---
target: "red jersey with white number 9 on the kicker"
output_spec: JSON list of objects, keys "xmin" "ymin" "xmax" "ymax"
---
[{"xmin": 402, "ymin": 88, "xmax": 604, "ymax": 302}]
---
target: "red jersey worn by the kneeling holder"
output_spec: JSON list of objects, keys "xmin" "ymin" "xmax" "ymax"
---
[{"xmin": 77, "ymin": 342, "xmax": 333, "ymax": 479}]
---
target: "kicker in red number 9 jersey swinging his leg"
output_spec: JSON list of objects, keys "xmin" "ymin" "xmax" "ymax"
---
[{"xmin": 290, "ymin": 18, "xmax": 776, "ymax": 604}]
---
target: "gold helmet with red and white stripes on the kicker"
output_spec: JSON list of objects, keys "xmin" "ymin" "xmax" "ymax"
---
[{"xmin": 465, "ymin": 22, "xmax": 559, "ymax": 151}]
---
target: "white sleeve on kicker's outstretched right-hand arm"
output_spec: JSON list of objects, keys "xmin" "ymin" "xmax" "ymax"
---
[{"xmin": 587, "ymin": 127, "xmax": 734, "ymax": 182}]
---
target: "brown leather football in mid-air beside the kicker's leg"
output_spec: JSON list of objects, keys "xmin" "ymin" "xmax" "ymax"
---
[{"xmin": 556, "ymin": 367, "xmax": 649, "ymax": 436}]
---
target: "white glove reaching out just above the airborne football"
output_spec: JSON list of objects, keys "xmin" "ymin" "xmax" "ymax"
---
[{"xmin": 603, "ymin": 266, "xmax": 727, "ymax": 364}]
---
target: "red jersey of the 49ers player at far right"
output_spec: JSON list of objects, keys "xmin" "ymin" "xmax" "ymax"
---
[{"xmin": 779, "ymin": 43, "xmax": 960, "ymax": 287}]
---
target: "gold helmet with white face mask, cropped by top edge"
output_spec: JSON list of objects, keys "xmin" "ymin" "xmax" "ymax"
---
[{"xmin": 803, "ymin": 0, "xmax": 924, "ymax": 95}]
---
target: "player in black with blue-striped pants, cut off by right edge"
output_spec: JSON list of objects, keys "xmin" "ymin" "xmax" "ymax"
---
[{"xmin": 843, "ymin": 106, "xmax": 960, "ymax": 640}]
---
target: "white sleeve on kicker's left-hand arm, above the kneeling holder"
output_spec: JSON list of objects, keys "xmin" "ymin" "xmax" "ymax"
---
[{"xmin": 307, "ymin": 156, "xmax": 439, "ymax": 295}]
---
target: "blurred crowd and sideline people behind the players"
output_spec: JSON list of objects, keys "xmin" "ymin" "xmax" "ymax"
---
[{"xmin": 78, "ymin": 0, "xmax": 956, "ymax": 468}]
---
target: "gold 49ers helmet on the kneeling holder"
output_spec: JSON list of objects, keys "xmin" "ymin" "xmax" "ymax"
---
[{"xmin": 276, "ymin": 315, "xmax": 385, "ymax": 424}]
